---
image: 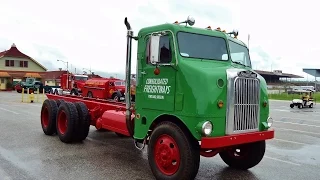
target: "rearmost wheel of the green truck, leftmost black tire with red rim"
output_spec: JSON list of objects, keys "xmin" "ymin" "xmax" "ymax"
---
[{"xmin": 40, "ymin": 99, "xmax": 58, "ymax": 135}]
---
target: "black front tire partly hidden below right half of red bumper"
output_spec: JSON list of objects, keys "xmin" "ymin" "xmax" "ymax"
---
[{"xmin": 219, "ymin": 141, "xmax": 266, "ymax": 170}]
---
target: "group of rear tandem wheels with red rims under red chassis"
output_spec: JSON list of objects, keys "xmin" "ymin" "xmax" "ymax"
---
[{"xmin": 41, "ymin": 99, "xmax": 90, "ymax": 143}]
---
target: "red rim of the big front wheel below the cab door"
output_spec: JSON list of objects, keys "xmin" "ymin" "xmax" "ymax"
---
[{"xmin": 154, "ymin": 134, "xmax": 180, "ymax": 176}]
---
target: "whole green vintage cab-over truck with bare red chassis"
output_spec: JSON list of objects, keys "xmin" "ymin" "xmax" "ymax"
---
[{"xmin": 41, "ymin": 17, "xmax": 274, "ymax": 180}]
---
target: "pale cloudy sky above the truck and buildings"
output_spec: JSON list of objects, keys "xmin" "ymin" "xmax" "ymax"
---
[{"xmin": 0, "ymin": 0, "xmax": 320, "ymax": 79}]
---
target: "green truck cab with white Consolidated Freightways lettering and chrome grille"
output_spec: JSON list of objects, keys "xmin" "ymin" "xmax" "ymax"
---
[{"xmin": 135, "ymin": 17, "xmax": 269, "ymax": 140}]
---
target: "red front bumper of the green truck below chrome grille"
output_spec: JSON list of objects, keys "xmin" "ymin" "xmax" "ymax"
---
[{"xmin": 201, "ymin": 129, "xmax": 274, "ymax": 149}]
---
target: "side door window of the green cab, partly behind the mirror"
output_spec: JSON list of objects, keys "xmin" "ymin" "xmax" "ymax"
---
[{"xmin": 146, "ymin": 36, "xmax": 172, "ymax": 64}]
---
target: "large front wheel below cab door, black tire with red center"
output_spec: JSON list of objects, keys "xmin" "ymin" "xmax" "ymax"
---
[{"xmin": 148, "ymin": 122, "xmax": 200, "ymax": 180}]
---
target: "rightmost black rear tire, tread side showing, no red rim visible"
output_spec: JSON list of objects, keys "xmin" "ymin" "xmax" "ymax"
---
[{"xmin": 74, "ymin": 102, "xmax": 90, "ymax": 141}]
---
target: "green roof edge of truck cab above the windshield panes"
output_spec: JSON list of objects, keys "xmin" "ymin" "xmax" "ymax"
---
[{"xmin": 138, "ymin": 23, "xmax": 247, "ymax": 47}]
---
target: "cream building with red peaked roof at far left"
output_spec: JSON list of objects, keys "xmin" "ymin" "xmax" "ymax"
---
[{"xmin": 0, "ymin": 44, "xmax": 47, "ymax": 90}]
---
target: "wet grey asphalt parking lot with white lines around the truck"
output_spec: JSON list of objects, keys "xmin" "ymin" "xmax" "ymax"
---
[{"xmin": 0, "ymin": 92, "xmax": 320, "ymax": 180}]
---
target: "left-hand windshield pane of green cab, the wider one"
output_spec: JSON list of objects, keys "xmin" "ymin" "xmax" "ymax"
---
[{"xmin": 177, "ymin": 32, "xmax": 228, "ymax": 61}]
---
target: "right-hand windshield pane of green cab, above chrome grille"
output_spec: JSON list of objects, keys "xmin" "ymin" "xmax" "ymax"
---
[{"xmin": 229, "ymin": 40, "xmax": 251, "ymax": 67}]
